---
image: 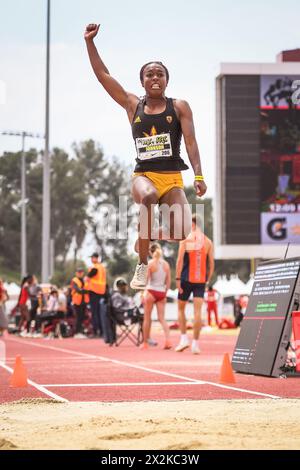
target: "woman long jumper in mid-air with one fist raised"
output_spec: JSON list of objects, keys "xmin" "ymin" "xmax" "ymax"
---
[{"xmin": 84, "ymin": 24, "xmax": 206, "ymax": 289}]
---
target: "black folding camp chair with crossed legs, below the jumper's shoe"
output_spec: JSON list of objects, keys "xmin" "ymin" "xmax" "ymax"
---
[{"xmin": 110, "ymin": 306, "xmax": 144, "ymax": 346}]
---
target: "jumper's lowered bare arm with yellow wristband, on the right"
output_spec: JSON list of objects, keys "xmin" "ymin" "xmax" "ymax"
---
[{"xmin": 175, "ymin": 100, "xmax": 207, "ymax": 196}]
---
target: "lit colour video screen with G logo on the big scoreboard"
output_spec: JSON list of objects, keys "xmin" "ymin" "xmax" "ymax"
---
[{"xmin": 260, "ymin": 75, "xmax": 300, "ymax": 244}]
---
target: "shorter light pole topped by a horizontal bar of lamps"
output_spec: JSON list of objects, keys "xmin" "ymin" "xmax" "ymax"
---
[{"xmin": 1, "ymin": 131, "xmax": 44, "ymax": 278}]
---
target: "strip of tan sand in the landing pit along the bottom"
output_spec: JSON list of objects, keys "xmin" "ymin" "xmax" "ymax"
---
[{"xmin": 0, "ymin": 399, "xmax": 300, "ymax": 450}]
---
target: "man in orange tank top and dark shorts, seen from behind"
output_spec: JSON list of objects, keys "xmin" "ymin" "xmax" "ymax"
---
[{"xmin": 175, "ymin": 215, "xmax": 215, "ymax": 354}]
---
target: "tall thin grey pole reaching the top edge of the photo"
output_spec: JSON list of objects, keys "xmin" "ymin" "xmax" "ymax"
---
[{"xmin": 42, "ymin": 0, "xmax": 51, "ymax": 282}]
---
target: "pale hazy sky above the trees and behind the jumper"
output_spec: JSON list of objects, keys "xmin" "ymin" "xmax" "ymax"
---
[{"xmin": 0, "ymin": 0, "xmax": 300, "ymax": 196}]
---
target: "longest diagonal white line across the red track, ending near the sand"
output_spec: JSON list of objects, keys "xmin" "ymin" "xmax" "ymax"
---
[{"xmin": 6, "ymin": 339, "xmax": 282, "ymax": 399}]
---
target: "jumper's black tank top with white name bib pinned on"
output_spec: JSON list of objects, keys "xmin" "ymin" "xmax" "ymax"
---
[{"xmin": 132, "ymin": 97, "xmax": 189, "ymax": 172}]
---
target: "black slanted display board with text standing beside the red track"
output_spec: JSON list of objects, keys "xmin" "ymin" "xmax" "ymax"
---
[{"xmin": 232, "ymin": 257, "xmax": 300, "ymax": 377}]
